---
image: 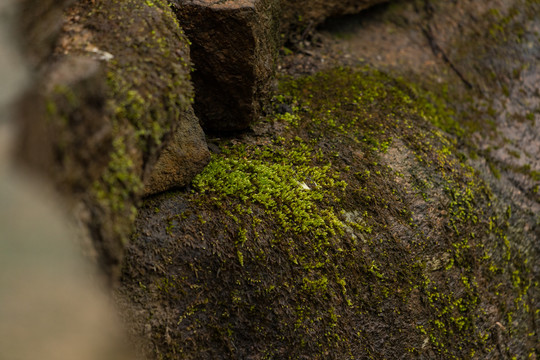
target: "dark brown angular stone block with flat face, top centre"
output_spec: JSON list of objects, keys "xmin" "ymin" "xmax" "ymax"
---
[{"xmin": 173, "ymin": 0, "xmax": 279, "ymax": 132}]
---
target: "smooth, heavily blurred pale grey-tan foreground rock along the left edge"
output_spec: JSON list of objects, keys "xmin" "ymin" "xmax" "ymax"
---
[{"xmin": 0, "ymin": 1, "xmax": 134, "ymax": 360}]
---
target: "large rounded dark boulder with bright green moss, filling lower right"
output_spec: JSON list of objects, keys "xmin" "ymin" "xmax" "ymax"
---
[{"xmin": 119, "ymin": 68, "xmax": 540, "ymax": 359}]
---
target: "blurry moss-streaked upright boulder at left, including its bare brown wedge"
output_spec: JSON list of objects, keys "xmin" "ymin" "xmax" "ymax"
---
[{"xmin": 16, "ymin": 0, "xmax": 209, "ymax": 273}]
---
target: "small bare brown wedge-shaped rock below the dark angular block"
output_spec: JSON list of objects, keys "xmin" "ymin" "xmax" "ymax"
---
[{"xmin": 144, "ymin": 110, "xmax": 210, "ymax": 195}]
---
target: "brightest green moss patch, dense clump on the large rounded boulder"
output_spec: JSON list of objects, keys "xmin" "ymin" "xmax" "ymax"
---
[{"xmin": 193, "ymin": 139, "xmax": 346, "ymax": 267}]
